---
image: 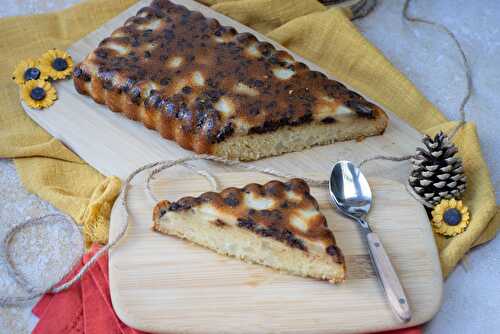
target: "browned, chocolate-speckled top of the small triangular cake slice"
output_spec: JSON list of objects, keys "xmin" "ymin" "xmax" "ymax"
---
[{"xmin": 153, "ymin": 179, "xmax": 344, "ymax": 264}]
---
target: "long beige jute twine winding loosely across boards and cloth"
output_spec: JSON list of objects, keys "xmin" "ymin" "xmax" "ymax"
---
[{"xmin": 0, "ymin": 0, "xmax": 473, "ymax": 306}]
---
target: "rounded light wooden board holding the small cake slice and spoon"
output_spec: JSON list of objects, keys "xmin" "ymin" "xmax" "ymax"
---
[{"xmin": 109, "ymin": 172, "xmax": 442, "ymax": 334}]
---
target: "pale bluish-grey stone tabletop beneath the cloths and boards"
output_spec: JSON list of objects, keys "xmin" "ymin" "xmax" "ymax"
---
[{"xmin": 0, "ymin": 0, "xmax": 500, "ymax": 334}]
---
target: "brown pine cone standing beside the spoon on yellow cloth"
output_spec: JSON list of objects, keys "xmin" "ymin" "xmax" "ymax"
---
[{"xmin": 408, "ymin": 132, "xmax": 466, "ymax": 205}]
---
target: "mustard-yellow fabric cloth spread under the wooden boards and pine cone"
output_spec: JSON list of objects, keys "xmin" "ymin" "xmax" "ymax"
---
[{"xmin": 0, "ymin": 0, "xmax": 500, "ymax": 276}]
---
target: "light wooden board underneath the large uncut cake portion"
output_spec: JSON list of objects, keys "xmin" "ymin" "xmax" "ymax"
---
[{"xmin": 23, "ymin": 0, "xmax": 421, "ymax": 180}]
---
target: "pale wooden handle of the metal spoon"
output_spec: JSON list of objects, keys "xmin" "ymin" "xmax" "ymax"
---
[{"xmin": 366, "ymin": 232, "xmax": 411, "ymax": 322}]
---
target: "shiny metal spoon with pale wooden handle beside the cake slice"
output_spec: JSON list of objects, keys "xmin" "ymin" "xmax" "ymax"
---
[{"xmin": 330, "ymin": 161, "xmax": 411, "ymax": 322}]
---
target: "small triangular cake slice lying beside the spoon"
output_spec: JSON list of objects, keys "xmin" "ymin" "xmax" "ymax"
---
[{"xmin": 153, "ymin": 179, "xmax": 345, "ymax": 283}]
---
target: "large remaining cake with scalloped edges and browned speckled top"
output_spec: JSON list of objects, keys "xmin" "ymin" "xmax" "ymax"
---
[{"xmin": 73, "ymin": 0, "xmax": 387, "ymax": 160}]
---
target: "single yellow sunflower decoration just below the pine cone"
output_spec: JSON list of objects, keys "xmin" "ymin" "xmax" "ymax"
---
[{"xmin": 432, "ymin": 198, "xmax": 470, "ymax": 236}]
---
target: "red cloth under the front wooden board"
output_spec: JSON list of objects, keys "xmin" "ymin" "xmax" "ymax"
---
[{"xmin": 33, "ymin": 246, "xmax": 422, "ymax": 334}]
